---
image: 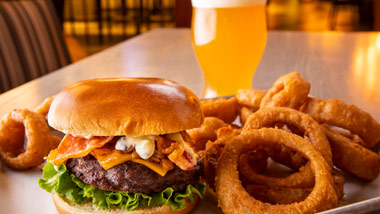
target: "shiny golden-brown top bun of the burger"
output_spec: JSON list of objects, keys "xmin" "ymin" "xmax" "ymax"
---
[{"xmin": 48, "ymin": 78, "xmax": 203, "ymax": 137}]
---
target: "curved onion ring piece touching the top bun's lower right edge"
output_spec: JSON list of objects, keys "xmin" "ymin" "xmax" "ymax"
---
[{"xmin": 186, "ymin": 117, "xmax": 228, "ymax": 151}]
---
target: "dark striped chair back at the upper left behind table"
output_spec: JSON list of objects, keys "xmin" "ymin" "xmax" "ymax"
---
[{"xmin": 0, "ymin": 0, "xmax": 71, "ymax": 92}]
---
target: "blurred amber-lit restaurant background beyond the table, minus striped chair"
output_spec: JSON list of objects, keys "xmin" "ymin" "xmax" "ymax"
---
[{"xmin": 60, "ymin": 0, "xmax": 380, "ymax": 57}]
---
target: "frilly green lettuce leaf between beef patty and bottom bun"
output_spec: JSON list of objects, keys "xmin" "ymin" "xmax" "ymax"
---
[{"xmin": 38, "ymin": 162, "xmax": 206, "ymax": 210}]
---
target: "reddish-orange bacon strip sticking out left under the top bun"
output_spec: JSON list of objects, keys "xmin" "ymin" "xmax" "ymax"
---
[{"xmin": 46, "ymin": 134, "xmax": 113, "ymax": 166}]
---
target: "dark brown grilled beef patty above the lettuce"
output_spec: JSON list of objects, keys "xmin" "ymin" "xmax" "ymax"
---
[{"xmin": 66, "ymin": 155, "xmax": 203, "ymax": 194}]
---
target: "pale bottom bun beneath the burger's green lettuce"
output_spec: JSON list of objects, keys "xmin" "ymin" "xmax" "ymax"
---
[{"xmin": 53, "ymin": 194, "xmax": 199, "ymax": 214}]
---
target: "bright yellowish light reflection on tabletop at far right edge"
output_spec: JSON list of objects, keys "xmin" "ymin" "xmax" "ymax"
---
[{"xmin": 353, "ymin": 34, "xmax": 380, "ymax": 98}]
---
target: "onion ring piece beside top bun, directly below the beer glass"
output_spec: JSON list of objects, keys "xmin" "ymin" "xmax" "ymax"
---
[{"xmin": 201, "ymin": 97, "xmax": 239, "ymax": 123}]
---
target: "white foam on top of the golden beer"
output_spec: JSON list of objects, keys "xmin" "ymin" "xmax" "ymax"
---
[{"xmin": 191, "ymin": 0, "xmax": 266, "ymax": 8}]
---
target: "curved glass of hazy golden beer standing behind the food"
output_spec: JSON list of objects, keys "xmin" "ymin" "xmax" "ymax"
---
[{"xmin": 192, "ymin": 0, "xmax": 267, "ymax": 98}]
